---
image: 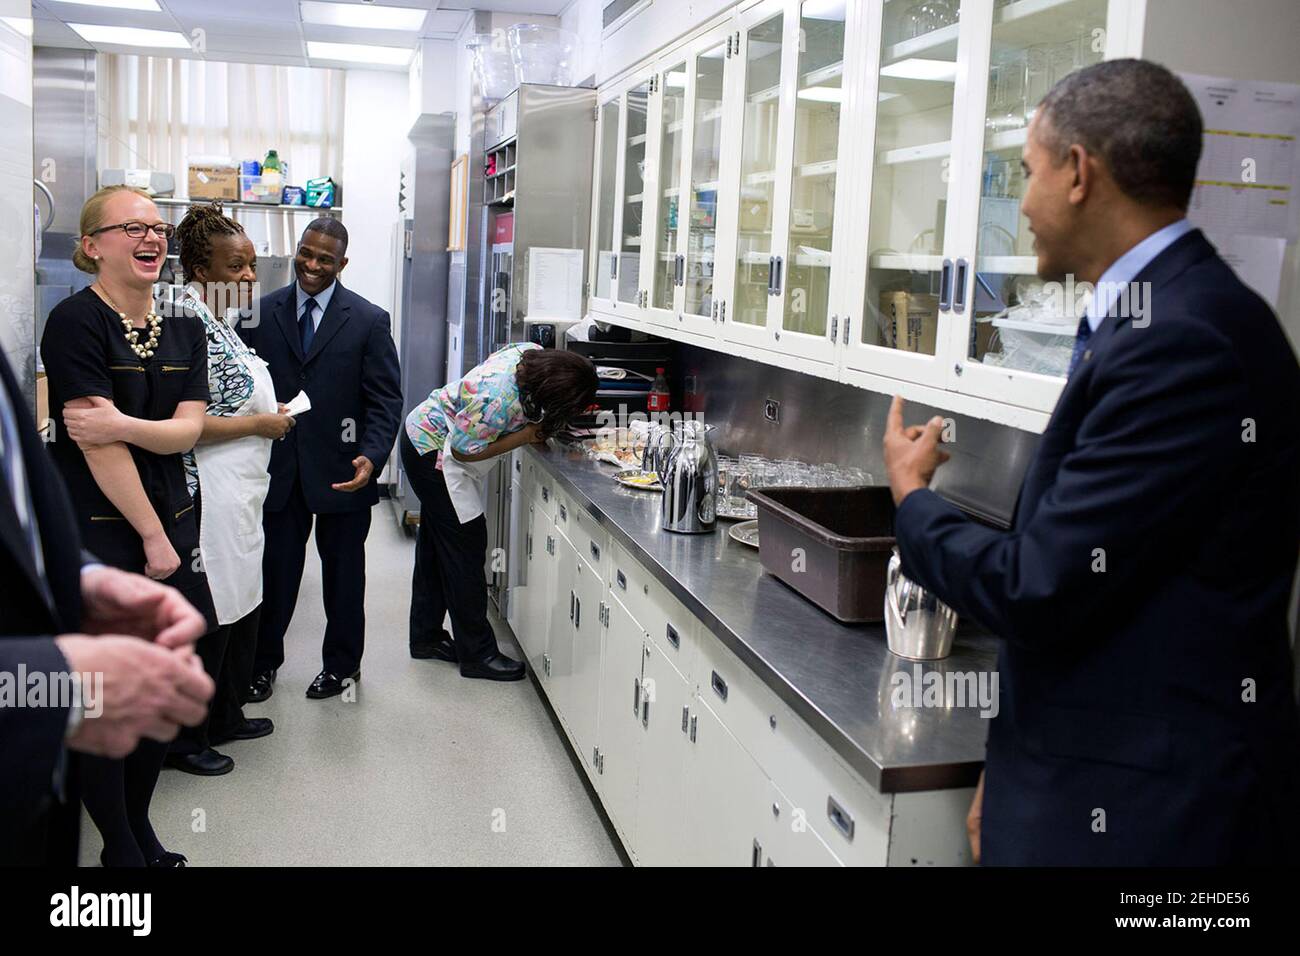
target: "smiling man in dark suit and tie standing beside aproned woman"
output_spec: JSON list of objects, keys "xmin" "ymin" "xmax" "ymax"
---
[{"xmin": 241, "ymin": 219, "xmax": 402, "ymax": 701}]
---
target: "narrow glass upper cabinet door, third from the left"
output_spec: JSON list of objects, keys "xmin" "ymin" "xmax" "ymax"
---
[{"xmin": 644, "ymin": 60, "xmax": 686, "ymax": 321}]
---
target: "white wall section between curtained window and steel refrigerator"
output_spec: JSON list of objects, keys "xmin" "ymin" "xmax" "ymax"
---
[{"xmin": 342, "ymin": 70, "xmax": 411, "ymax": 313}]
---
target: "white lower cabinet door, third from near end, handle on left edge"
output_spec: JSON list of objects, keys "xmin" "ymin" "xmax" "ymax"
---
[{"xmin": 626, "ymin": 639, "xmax": 690, "ymax": 866}]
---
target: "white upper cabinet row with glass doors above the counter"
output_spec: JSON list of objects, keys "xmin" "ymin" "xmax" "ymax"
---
[{"xmin": 590, "ymin": 0, "xmax": 1145, "ymax": 428}]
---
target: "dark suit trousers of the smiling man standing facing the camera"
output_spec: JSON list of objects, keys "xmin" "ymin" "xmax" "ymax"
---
[{"xmin": 254, "ymin": 481, "xmax": 371, "ymax": 678}]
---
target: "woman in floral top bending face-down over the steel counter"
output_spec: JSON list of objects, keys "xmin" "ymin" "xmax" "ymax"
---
[{"xmin": 400, "ymin": 343, "xmax": 597, "ymax": 680}]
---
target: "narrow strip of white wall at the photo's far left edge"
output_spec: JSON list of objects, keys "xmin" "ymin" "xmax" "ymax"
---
[{"xmin": 0, "ymin": 0, "xmax": 36, "ymax": 402}]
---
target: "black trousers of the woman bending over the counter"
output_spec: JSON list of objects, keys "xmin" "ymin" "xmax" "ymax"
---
[{"xmin": 402, "ymin": 431, "xmax": 498, "ymax": 663}]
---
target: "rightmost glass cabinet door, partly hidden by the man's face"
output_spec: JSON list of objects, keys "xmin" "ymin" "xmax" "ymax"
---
[{"xmin": 954, "ymin": 0, "xmax": 1109, "ymax": 411}]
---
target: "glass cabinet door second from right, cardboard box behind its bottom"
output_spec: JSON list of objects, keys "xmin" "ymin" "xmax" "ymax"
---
[{"xmin": 845, "ymin": 0, "xmax": 977, "ymax": 385}]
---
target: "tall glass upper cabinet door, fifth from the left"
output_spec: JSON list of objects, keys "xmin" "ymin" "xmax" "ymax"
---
[{"xmin": 724, "ymin": 3, "xmax": 787, "ymax": 347}]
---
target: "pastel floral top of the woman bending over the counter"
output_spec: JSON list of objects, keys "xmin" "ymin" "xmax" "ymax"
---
[{"xmin": 406, "ymin": 342, "xmax": 541, "ymax": 468}]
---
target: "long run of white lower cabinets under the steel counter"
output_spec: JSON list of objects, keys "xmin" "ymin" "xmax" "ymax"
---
[{"xmin": 511, "ymin": 463, "xmax": 970, "ymax": 866}]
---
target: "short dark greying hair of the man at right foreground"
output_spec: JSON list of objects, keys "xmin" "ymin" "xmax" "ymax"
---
[{"xmin": 1039, "ymin": 60, "xmax": 1201, "ymax": 209}]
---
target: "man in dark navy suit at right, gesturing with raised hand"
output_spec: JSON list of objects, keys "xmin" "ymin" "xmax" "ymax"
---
[{"xmin": 885, "ymin": 60, "xmax": 1300, "ymax": 865}]
